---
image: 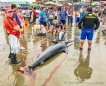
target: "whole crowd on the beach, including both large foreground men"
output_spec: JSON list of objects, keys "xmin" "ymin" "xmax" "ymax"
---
[{"xmin": 1, "ymin": 4, "xmax": 106, "ymax": 64}]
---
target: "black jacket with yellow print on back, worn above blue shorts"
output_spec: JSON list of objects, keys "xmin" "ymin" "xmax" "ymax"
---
[{"xmin": 78, "ymin": 13, "xmax": 100, "ymax": 30}]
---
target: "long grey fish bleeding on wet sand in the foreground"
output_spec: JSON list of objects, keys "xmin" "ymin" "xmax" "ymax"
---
[{"xmin": 25, "ymin": 41, "xmax": 72, "ymax": 76}]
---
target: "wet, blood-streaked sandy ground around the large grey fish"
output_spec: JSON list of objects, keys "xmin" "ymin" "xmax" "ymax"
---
[{"xmin": 0, "ymin": 16, "xmax": 106, "ymax": 86}]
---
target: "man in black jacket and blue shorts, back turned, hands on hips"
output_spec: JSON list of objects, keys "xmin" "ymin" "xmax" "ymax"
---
[{"xmin": 78, "ymin": 7, "xmax": 100, "ymax": 52}]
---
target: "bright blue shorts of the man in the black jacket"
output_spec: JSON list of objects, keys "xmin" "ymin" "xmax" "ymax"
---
[{"xmin": 81, "ymin": 28, "xmax": 94, "ymax": 40}]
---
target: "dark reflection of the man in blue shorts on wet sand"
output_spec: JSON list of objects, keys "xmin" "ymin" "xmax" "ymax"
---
[{"xmin": 74, "ymin": 54, "xmax": 93, "ymax": 82}]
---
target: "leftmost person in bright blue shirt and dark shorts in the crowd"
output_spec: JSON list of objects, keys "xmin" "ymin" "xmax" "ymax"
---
[{"xmin": 40, "ymin": 7, "xmax": 48, "ymax": 31}]
